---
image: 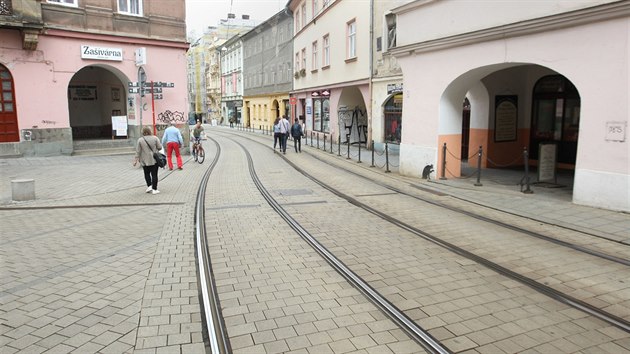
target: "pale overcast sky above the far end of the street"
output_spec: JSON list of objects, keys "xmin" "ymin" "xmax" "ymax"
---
[{"xmin": 186, "ymin": 0, "xmax": 288, "ymax": 37}]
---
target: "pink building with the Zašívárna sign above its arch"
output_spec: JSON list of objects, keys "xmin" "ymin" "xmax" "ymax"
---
[{"xmin": 0, "ymin": 1, "xmax": 188, "ymax": 156}]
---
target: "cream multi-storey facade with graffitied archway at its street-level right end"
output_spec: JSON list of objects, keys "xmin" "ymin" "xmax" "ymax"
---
[{"xmin": 288, "ymin": 0, "xmax": 371, "ymax": 144}]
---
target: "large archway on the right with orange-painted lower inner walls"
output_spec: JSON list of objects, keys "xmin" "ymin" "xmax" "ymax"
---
[{"xmin": 436, "ymin": 63, "xmax": 580, "ymax": 187}]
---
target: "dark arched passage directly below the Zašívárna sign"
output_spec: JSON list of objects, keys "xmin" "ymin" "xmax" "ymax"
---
[{"xmin": 68, "ymin": 65, "xmax": 129, "ymax": 140}]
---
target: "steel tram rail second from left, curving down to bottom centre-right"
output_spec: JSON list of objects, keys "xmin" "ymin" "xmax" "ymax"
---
[{"xmin": 234, "ymin": 141, "xmax": 451, "ymax": 354}]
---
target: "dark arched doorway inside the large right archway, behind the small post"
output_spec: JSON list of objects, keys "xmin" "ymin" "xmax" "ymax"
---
[{"xmin": 529, "ymin": 75, "xmax": 580, "ymax": 167}]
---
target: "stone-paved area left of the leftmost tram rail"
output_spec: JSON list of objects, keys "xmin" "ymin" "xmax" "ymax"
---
[{"xmin": 0, "ymin": 155, "xmax": 206, "ymax": 354}]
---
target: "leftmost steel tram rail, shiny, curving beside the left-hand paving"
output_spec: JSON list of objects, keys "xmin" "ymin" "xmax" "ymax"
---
[{"xmin": 195, "ymin": 139, "xmax": 232, "ymax": 354}]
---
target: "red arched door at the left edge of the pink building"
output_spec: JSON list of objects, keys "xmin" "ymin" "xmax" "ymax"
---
[{"xmin": 0, "ymin": 65, "xmax": 20, "ymax": 143}]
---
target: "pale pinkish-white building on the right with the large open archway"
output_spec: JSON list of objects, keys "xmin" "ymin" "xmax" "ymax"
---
[{"xmin": 389, "ymin": 0, "xmax": 630, "ymax": 211}]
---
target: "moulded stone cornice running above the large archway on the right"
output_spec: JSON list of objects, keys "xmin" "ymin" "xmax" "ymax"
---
[{"xmin": 389, "ymin": 1, "xmax": 630, "ymax": 58}]
